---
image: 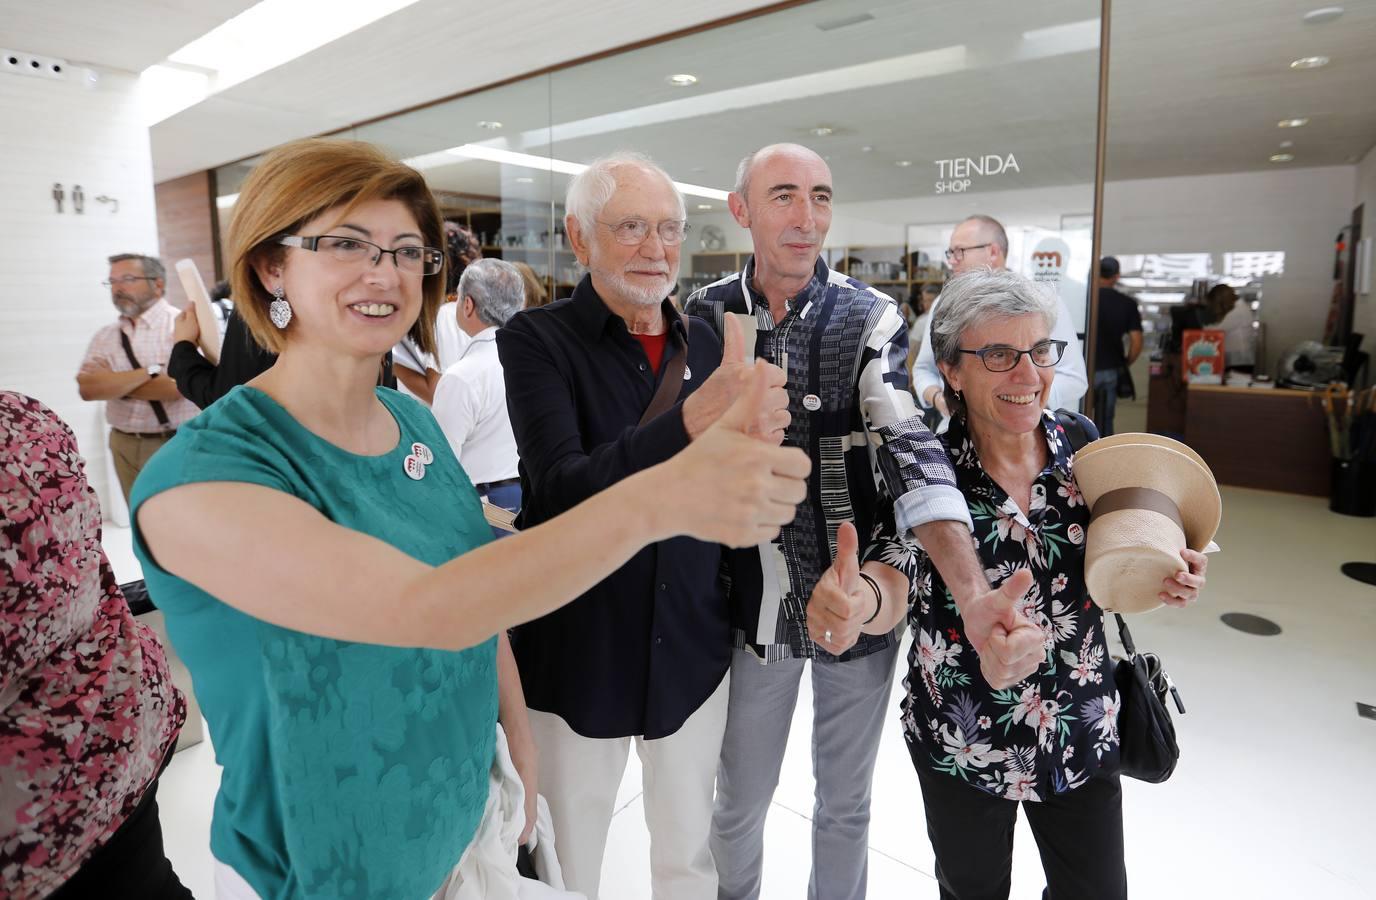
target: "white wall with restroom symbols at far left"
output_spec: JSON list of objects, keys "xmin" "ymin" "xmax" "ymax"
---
[{"xmin": 0, "ymin": 72, "xmax": 158, "ymax": 512}]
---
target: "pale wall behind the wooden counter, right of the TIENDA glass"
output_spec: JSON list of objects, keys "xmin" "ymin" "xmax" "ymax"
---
[{"xmin": 1104, "ymin": 165, "xmax": 1355, "ymax": 367}]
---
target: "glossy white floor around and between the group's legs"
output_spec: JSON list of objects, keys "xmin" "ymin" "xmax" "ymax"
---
[{"xmin": 126, "ymin": 489, "xmax": 1376, "ymax": 900}]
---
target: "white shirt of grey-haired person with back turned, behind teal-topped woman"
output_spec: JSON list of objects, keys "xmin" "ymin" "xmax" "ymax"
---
[{"xmin": 431, "ymin": 328, "xmax": 519, "ymax": 484}]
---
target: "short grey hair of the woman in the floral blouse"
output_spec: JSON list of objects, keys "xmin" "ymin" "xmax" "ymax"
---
[{"xmin": 932, "ymin": 266, "xmax": 1057, "ymax": 410}]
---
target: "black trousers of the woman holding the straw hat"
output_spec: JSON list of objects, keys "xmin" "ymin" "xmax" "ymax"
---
[{"xmin": 912, "ymin": 747, "xmax": 1127, "ymax": 900}]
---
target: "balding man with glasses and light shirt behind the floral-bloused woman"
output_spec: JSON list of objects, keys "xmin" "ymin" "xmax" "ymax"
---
[{"xmin": 912, "ymin": 215, "xmax": 1090, "ymax": 429}]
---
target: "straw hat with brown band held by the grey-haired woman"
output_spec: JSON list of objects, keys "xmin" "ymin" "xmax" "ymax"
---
[{"xmin": 1075, "ymin": 433, "xmax": 1223, "ymax": 612}]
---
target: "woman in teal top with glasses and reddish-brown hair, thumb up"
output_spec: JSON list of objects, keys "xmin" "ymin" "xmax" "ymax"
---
[{"xmin": 133, "ymin": 140, "xmax": 809, "ymax": 900}]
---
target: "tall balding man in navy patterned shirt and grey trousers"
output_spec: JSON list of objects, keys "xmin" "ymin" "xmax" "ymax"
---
[{"xmin": 685, "ymin": 144, "xmax": 1042, "ymax": 900}]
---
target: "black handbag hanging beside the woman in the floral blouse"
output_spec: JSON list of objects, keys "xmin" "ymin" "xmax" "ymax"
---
[{"xmin": 1113, "ymin": 612, "xmax": 1185, "ymax": 784}]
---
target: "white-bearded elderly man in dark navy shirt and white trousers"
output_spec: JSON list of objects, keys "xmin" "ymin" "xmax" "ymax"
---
[{"xmin": 497, "ymin": 153, "xmax": 788, "ymax": 900}]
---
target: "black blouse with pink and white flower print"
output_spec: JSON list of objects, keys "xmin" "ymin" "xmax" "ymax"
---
[{"xmin": 903, "ymin": 411, "xmax": 1119, "ymax": 801}]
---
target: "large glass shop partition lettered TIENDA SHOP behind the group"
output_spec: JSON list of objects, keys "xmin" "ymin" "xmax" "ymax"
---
[{"xmin": 216, "ymin": 0, "xmax": 1099, "ymax": 342}]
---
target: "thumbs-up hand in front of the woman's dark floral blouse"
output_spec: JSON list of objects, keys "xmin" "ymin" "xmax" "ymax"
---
[{"xmin": 960, "ymin": 568, "xmax": 1046, "ymax": 689}]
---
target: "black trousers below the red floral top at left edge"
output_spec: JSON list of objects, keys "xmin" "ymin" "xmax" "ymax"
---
[{"xmin": 48, "ymin": 782, "xmax": 191, "ymax": 900}]
